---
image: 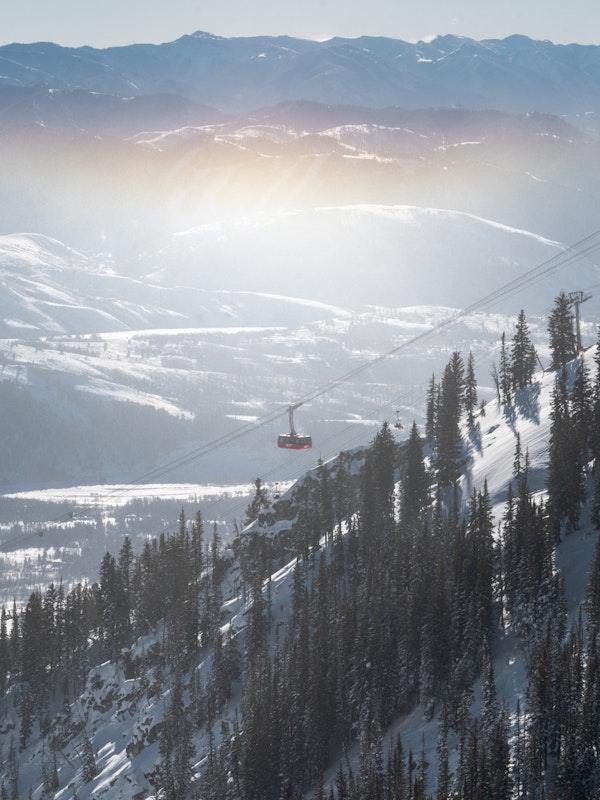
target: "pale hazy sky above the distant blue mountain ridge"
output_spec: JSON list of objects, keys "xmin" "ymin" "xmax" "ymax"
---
[{"xmin": 0, "ymin": 0, "xmax": 600, "ymax": 47}]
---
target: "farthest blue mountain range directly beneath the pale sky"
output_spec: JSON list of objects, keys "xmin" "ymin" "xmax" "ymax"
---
[{"xmin": 0, "ymin": 31, "xmax": 600, "ymax": 124}]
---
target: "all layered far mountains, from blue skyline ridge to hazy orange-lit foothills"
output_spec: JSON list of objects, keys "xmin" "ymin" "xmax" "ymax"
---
[{"xmin": 0, "ymin": 32, "xmax": 600, "ymax": 250}]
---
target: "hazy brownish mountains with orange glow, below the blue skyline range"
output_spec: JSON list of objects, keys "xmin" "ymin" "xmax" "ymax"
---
[{"xmin": 0, "ymin": 103, "xmax": 600, "ymax": 255}]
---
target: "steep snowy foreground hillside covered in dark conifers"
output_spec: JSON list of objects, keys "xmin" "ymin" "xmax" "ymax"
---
[{"xmin": 0, "ymin": 304, "xmax": 600, "ymax": 800}]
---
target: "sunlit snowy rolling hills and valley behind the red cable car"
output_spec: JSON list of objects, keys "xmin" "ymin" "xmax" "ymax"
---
[{"xmin": 0, "ymin": 205, "xmax": 600, "ymax": 489}]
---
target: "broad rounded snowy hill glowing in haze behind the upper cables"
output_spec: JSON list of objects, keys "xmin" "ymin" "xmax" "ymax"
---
[{"xmin": 159, "ymin": 205, "xmax": 599, "ymax": 314}]
